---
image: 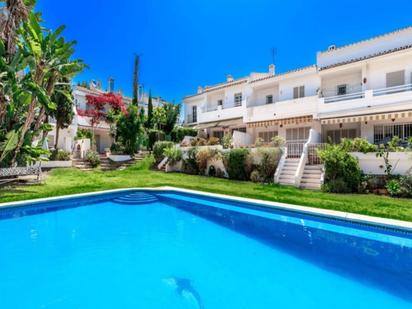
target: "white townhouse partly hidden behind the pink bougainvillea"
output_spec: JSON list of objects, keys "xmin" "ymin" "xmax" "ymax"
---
[{"xmin": 48, "ymin": 82, "xmax": 166, "ymax": 155}]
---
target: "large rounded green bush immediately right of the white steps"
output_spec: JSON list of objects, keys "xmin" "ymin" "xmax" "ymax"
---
[{"xmin": 319, "ymin": 145, "xmax": 362, "ymax": 193}]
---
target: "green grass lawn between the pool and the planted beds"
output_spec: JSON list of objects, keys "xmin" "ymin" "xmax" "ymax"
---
[{"xmin": 0, "ymin": 162, "xmax": 412, "ymax": 221}]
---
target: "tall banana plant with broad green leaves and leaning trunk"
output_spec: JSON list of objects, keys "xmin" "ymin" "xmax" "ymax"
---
[{"xmin": 11, "ymin": 13, "xmax": 85, "ymax": 165}]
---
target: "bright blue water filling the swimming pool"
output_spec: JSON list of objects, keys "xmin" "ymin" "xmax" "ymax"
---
[{"xmin": 0, "ymin": 191, "xmax": 412, "ymax": 309}]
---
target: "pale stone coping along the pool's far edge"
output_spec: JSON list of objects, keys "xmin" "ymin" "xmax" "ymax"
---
[{"xmin": 0, "ymin": 186, "xmax": 412, "ymax": 232}]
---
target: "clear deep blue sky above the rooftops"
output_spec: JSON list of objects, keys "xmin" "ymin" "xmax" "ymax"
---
[{"xmin": 37, "ymin": 0, "xmax": 412, "ymax": 102}]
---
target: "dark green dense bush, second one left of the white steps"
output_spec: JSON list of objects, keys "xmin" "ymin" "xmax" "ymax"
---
[{"xmin": 225, "ymin": 148, "xmax": 251, "ymax": 180}]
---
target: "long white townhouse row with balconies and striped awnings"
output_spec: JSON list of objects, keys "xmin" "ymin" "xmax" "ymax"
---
[{"xmin": 183, "ymin": 27, "xmax": 412, "ymax": 147}]
